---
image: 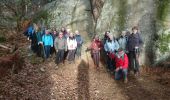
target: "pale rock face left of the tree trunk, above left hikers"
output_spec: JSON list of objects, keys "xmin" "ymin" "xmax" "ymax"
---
[{"xmin": 45, "ymin": 0, "xmax": 94, "ymax": 37}]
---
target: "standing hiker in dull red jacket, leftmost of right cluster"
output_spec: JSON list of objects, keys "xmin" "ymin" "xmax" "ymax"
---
[{"xmin": 88, "ymin": 35, "xmax": 102, "ymax": 68}]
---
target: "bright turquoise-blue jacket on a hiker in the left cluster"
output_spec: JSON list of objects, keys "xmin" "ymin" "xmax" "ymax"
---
[{"xmin": 42, "ymin": 34, "xmax": 53, "ymax": 47}]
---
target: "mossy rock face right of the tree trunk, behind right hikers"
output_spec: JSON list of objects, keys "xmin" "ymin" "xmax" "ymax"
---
[{"xmin": 95, "ymin": 0, "xmax": 170, "ymax": 65}]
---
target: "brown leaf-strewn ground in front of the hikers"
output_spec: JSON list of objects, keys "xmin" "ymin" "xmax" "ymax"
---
[{"xmin": 0, "ymin": 33, "xmax": 170, "ymax": 100}]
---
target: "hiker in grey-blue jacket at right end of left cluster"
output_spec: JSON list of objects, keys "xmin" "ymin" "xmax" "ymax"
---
[{"xmin": 75, "ymin": 30, "xmax": 83, "ymax": 58}]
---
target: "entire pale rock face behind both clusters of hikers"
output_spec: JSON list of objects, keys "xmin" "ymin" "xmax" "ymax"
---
[{"xmin": 44, "ymin": 0, "xmax": 170, "ymax": 65}]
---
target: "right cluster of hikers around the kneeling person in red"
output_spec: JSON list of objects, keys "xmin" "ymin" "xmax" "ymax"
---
[{"xmin": 89, "ymin": 26, "xmax": 143, "ymax": 83}]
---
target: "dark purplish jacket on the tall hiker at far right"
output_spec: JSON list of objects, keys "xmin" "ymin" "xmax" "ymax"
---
[{"xmin": 126, "ymin": 33, "xmax": 143, "ymax": 51}]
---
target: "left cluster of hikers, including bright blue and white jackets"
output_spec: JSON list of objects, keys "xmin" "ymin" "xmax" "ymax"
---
[{"xmin": 24, "ymin": 24, "xmax": 83, "ymax": 68}]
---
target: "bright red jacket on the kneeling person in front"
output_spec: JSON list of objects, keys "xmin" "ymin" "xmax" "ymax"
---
[{"xmin": 115, "ymin": 54, "xmax": 128, "ymax": 69}]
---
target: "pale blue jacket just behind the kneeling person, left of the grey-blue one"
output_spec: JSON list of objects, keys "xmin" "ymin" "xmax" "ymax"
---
[{"xmin": 104, "ymin": 40, "xmax": 119, "ymax": 52}]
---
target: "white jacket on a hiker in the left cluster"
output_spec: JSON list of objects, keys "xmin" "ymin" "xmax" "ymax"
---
[{"xmin": 67, "ymin": 37, "xmax": 77, "ymax": 50}]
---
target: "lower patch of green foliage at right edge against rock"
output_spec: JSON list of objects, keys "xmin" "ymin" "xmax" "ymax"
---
[{"xmin": 157, "ymin": 32, "xmax": 170, "ymax": 54}]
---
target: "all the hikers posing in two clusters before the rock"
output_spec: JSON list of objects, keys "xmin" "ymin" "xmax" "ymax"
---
[{"xmin": 24, "ymin": 24, "xmax": 143, "ymax": 83}]
